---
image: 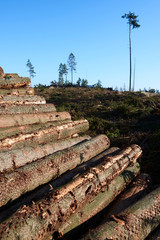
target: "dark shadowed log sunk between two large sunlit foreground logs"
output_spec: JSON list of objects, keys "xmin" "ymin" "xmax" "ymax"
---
[{"xmin": 0, "ymin": 147, "xmax": 119, "ymax": 223}]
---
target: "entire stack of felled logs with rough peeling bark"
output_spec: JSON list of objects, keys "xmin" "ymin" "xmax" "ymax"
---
[{"xmin": 0, "ymin": 68, "xmax": 160, "ymax": 240}]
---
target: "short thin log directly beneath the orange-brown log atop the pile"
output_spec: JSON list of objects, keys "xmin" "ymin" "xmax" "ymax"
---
[{"xmin": 0, "ymin": 87, "xmax": 34, "ymax": 96}]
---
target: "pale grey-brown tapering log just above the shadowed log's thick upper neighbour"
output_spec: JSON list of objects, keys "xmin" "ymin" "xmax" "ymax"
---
[{"xmin": 0, "ymin": 136, "xmax": 90, "ymax": 173}]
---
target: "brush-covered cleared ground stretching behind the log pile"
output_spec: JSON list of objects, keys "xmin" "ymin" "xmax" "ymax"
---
[{"xmin": 35, "ymin": 87, "xmax": 160, "ymax": 184}]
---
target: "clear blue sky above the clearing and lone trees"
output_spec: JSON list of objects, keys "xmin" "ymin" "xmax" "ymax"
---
[{"xmin": 0, "ymin": 0, "xmax": 160, "ymax": 90}]
